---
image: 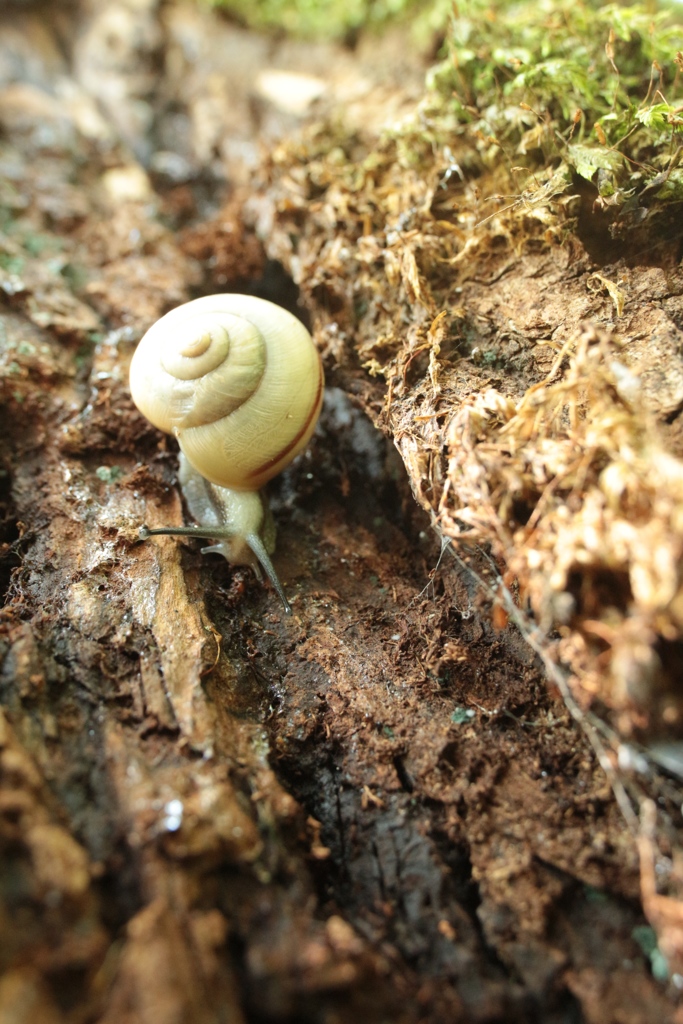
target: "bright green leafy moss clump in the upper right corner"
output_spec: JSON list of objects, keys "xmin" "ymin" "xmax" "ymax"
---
[{"xmin": 423, "ymin": 0, "xmax": 683, "ymax": 206}]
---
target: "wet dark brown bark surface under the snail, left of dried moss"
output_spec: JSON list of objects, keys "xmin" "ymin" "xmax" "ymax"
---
[{"xmin": 0, "ymin": 0, "xmax": 678, "ymax": 1024}]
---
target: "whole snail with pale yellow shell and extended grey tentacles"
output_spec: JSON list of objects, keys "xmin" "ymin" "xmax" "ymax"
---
[{"xmin": 130, "ymin": 294, "xmax": 324, "ymax": 614}]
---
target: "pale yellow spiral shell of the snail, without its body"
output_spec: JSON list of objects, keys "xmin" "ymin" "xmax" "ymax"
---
[{"xmin": 130, "ymin": 295, "xmax": 324, "ymax": 490}]
